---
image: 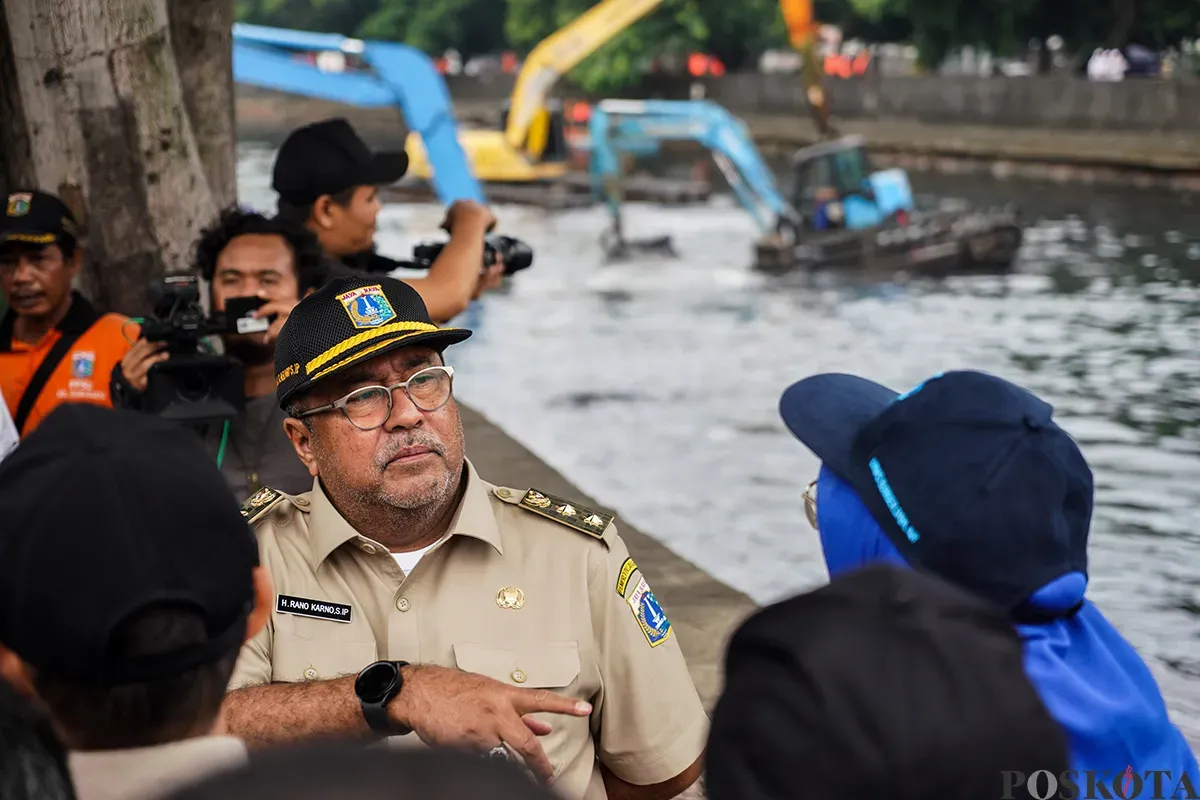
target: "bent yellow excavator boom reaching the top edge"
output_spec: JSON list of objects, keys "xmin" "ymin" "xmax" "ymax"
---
[{"xmin": 504, "ymin": 0, "xmax": 662, "ymax": 150}]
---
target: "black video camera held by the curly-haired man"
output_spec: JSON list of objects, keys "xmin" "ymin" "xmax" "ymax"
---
[{"xmin": 142, "ymin": 276, "xmax": 246, "ymax": 423}]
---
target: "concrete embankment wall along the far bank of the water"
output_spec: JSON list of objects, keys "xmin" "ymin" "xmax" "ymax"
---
[{"xmin": 238, "ymin": 74, "xmax": 1200, "ymax": 190}]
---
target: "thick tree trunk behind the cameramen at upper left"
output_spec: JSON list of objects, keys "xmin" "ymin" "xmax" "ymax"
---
[{"xmin": 0, "ymin": 0, "xmax": 236, "ymax": 314}]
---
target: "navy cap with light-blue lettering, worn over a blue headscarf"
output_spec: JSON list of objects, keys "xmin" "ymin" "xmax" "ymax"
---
[{"xmin": 780, "ymin": 371, "xmax": 1093, "ymax": 615}]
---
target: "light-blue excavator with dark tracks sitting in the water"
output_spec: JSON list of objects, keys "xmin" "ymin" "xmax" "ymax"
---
[{"xmin": 588, "ymin": 100, "xmax": 1021, "ymax": 273}]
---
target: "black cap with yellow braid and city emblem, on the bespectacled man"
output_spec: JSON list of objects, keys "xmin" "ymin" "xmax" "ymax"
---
[{"xmin": 275, "ymin": 276, "xmax": 472, "ymax": 408}]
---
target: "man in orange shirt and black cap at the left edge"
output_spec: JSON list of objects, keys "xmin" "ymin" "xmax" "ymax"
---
[{"xmin": 0, "ymin": 191, "xmax": 149, "ymax": 437}]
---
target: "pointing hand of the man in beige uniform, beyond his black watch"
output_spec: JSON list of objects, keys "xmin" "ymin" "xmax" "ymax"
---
[{"xmin": 388, "ymin": 666, "xmax": 592, "ymax": 783}]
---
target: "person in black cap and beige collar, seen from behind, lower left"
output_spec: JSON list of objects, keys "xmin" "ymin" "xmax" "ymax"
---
[{"xmin": 0, "ymin": 404, "xmax": 272, "ymax": 800}]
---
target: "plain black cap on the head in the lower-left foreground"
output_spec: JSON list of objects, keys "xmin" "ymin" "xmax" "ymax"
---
[{"xmin": 0, "ymin": 403, "xmax": 258, "ymax": 686}]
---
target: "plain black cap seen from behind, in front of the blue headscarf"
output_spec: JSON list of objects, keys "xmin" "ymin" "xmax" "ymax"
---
[{"xmin": 704, "ymin": 565, "xmax": 1069, "ymax": 800}]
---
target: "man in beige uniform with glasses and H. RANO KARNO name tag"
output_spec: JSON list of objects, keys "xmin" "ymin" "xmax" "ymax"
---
[{"xmin": 227, "ymin": 277, "xmax": 708, "ymax": 800}]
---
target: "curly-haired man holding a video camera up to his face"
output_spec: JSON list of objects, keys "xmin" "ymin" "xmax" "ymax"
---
[{"xmin": 113, "ymin": 207, "xmax": 328, "ymax": 499}]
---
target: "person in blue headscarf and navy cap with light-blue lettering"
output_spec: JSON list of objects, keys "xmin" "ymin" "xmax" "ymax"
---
[{"xmin": 780, "ymin": 371, "xmax": 1200, "ymax": 798}]
